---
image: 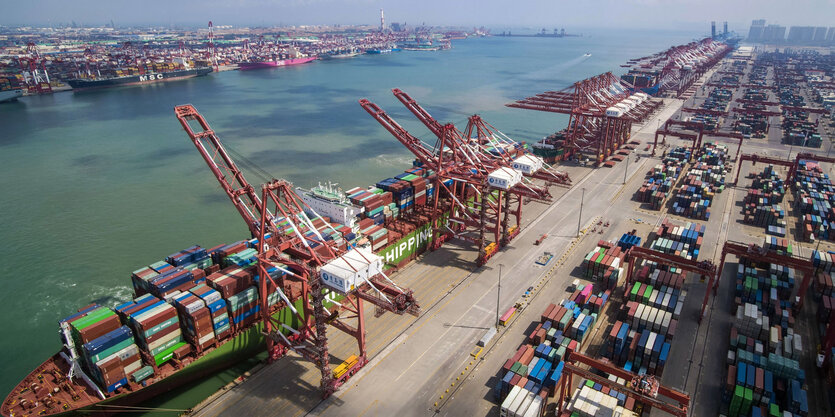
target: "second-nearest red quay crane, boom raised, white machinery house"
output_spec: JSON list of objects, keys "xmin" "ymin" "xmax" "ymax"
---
[{"xmin": 360, "ymin": 99, "xmax": 551, "ymax": 265}]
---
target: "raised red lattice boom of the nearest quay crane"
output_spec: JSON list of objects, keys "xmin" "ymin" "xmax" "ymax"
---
[{"xmin": 174, "ymin": 104, "xmax": 262, "ymax": 236}]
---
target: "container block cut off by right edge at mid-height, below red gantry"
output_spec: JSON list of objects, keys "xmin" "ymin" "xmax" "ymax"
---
[{"xmin": 793, "ymin": 160, "xmax": 835, "ymax": 241}]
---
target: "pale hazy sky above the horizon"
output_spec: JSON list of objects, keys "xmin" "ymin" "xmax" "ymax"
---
[{"xmin": 0, "ymin": 0, "xmax": 835, "ymax": 33}]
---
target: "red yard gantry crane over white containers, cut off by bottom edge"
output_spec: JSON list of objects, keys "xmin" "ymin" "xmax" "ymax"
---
[{"xmin": 557, "ymin": 352, "xmax": 690, "ymax": 417}]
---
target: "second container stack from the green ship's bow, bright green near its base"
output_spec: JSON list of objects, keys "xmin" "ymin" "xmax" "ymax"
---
[{"xmin": 116, "ymin": 294, "xmax": 188, "ymax": 368}]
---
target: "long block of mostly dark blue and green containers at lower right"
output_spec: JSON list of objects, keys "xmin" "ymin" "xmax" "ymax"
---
[{"xmin": 722, "ymin": 258, "xmax": 808, "ymax": 416}]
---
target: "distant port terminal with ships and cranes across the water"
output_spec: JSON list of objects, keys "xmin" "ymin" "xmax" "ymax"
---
[{"xmin": 0, "ymin": 22, "xmax": 476, "ymax": 94}]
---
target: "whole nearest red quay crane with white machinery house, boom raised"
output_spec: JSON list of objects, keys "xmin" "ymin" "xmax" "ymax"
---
[{"xmin": 175, "ymin": 105, "xmax": 420, "ymax": 397}]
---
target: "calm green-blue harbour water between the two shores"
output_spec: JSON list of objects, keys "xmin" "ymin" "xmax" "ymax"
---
[{"xmin": 0, "ymin": 31, "xmax": 697, "ymax": 408}]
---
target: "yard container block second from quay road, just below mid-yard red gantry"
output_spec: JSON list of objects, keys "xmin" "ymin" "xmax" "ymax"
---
[{"xmin": 670, "ymin": 143, "xmax": 728, "ymax": 220}]
